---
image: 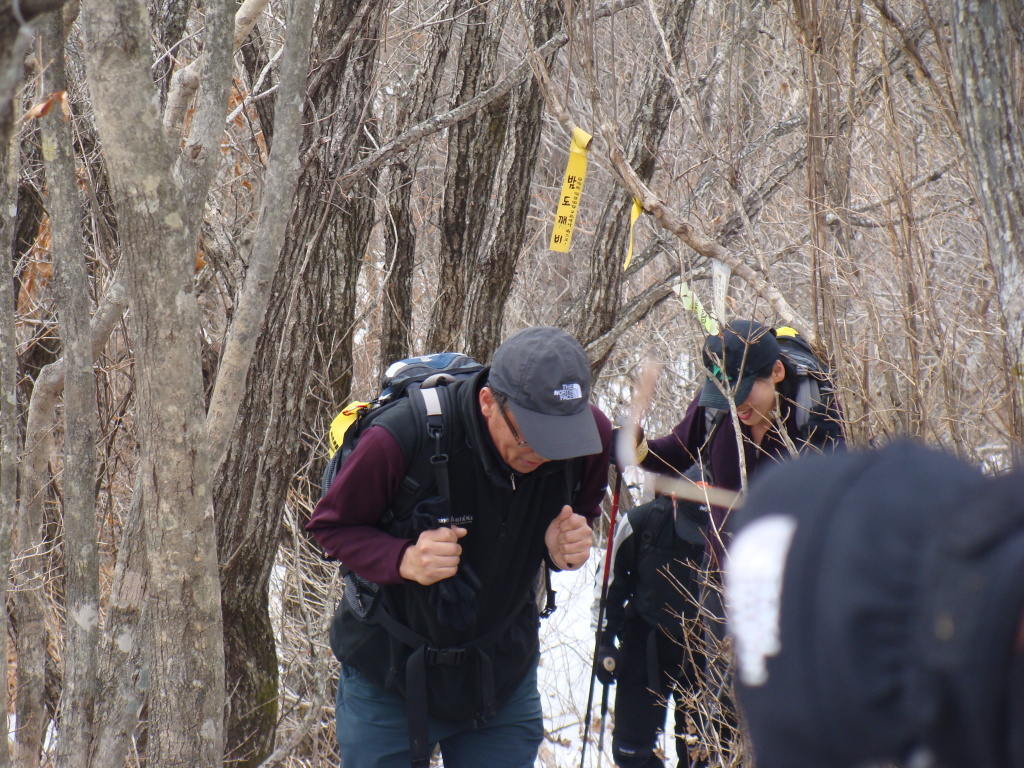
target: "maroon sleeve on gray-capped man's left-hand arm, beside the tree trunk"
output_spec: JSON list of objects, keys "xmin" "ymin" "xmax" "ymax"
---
[{"xmin": 306, "ymin": 426, "xmax": 412, "ymax": 584}]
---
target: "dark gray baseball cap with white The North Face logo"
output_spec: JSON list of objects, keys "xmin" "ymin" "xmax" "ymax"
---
[{"xmin": 488, "ymin": 326, "xmax": 602, "ymax": 460}]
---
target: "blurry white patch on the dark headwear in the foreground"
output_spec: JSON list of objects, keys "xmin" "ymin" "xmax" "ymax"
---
[{"xmin": 725, "ymin": 515, "xmax": 797, "ymax": 686}]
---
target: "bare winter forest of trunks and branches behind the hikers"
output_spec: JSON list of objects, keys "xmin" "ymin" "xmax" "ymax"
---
[{"xmin": 0, "ymin": 0, "xmax": 1024, "ymax": 768}]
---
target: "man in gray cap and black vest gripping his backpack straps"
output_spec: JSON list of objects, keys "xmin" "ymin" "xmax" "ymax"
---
[{"xmin": 307, "ymin": 327, "xmax": 611, "ymax": 768}]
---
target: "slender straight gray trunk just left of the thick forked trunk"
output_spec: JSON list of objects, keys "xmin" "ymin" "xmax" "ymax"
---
[{"xmin": 39, "ymin": 13, "xmax": 99, "ymax": 768}]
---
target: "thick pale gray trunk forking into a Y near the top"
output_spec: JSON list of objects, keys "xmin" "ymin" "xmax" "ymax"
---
[{"xmin": 83, "ymin": 0, "xmax": 233, "ymax": 766}]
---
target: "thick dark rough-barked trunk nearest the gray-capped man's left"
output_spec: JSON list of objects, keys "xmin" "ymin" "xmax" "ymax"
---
[{"xmin": 214, "ymin": 0, "xmax": 384, "ymax": 766}]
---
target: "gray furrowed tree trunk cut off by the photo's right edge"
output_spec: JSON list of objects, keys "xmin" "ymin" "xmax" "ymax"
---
[{"xmin": 951, "ymin": 0, "xmax": 1024, "ymax": 450}]
